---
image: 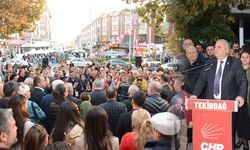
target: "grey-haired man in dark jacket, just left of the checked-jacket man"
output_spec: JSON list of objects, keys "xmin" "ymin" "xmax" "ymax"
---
[{"xmin": 90, "ymin": 79, "xmax": 107, "ymax": 106}]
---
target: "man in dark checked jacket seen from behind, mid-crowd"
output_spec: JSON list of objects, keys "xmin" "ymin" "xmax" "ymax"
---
[{"xmin": 100, "ymin": 86, "xmax": 127, "ymax": 134}]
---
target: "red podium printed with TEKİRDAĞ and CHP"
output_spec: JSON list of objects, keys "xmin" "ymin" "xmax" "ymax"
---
[{"xmin": 188, "ymin": 99, "xmax": 238, "ymax": 150}]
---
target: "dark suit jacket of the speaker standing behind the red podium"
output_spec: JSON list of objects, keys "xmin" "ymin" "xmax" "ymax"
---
[{"xmin": 193, "ymin": 56, "xmax": 247, "ymax": 100}]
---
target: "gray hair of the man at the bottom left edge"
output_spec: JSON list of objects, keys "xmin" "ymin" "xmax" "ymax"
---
[{"xmin": 0, "ymin": 108, "xmax": 13, "ymax": 133}]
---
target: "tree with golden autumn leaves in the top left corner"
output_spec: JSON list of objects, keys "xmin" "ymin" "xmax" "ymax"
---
[{"xmin": 0, "ymin": 0, "xmax": 45, "ymax": 38}]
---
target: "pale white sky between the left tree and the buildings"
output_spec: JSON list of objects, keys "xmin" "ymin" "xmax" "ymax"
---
[{"xmin": 47, "ymin": 0, "xmax": 129, "ymax": 43}]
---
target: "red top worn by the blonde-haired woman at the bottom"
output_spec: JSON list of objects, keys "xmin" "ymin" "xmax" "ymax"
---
[{"xmin": 119, "ymin": 132, "xmax": 137, "ymax": 150}]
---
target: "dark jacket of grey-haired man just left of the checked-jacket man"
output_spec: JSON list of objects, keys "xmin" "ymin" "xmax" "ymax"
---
[{"xmin": 90, "ymin": 90, "xmax": 107, "ymax": 106}]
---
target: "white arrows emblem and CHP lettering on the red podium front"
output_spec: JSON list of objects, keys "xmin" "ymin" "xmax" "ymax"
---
[{"xmin": 200, "ymin": 123, "xmax": 224, "ymax": 150}]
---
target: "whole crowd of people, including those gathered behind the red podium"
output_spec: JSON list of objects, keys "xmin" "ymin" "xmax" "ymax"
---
[{"xmin": 0, "ymin": 39, "xmax": 250, "ymax": 150}]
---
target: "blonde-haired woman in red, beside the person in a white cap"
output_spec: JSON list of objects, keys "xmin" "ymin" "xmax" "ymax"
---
[{"xmin": 120, "ymin": 109, "xmax": 153, "ymax": 150}]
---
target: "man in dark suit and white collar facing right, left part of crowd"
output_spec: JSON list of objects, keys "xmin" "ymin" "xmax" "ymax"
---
[{"xmin": 30, "ymin": 75, "xmax": 46, "ymax": 108}]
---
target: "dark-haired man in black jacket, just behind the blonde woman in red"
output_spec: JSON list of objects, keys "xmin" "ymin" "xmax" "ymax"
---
[{"xmin": 115, "ymin": 91, "xmax": 146, "ymax": 141}]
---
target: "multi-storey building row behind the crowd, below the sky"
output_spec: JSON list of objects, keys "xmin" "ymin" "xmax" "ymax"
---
[{"xmin": 76, "ymin": 9, "xmax": 167, "ymax": 49}]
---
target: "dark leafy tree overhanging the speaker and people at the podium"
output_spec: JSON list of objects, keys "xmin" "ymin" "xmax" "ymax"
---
[{"xmin": 136, "ymin": 0, "xmax": 249, "ymax": 54}]
